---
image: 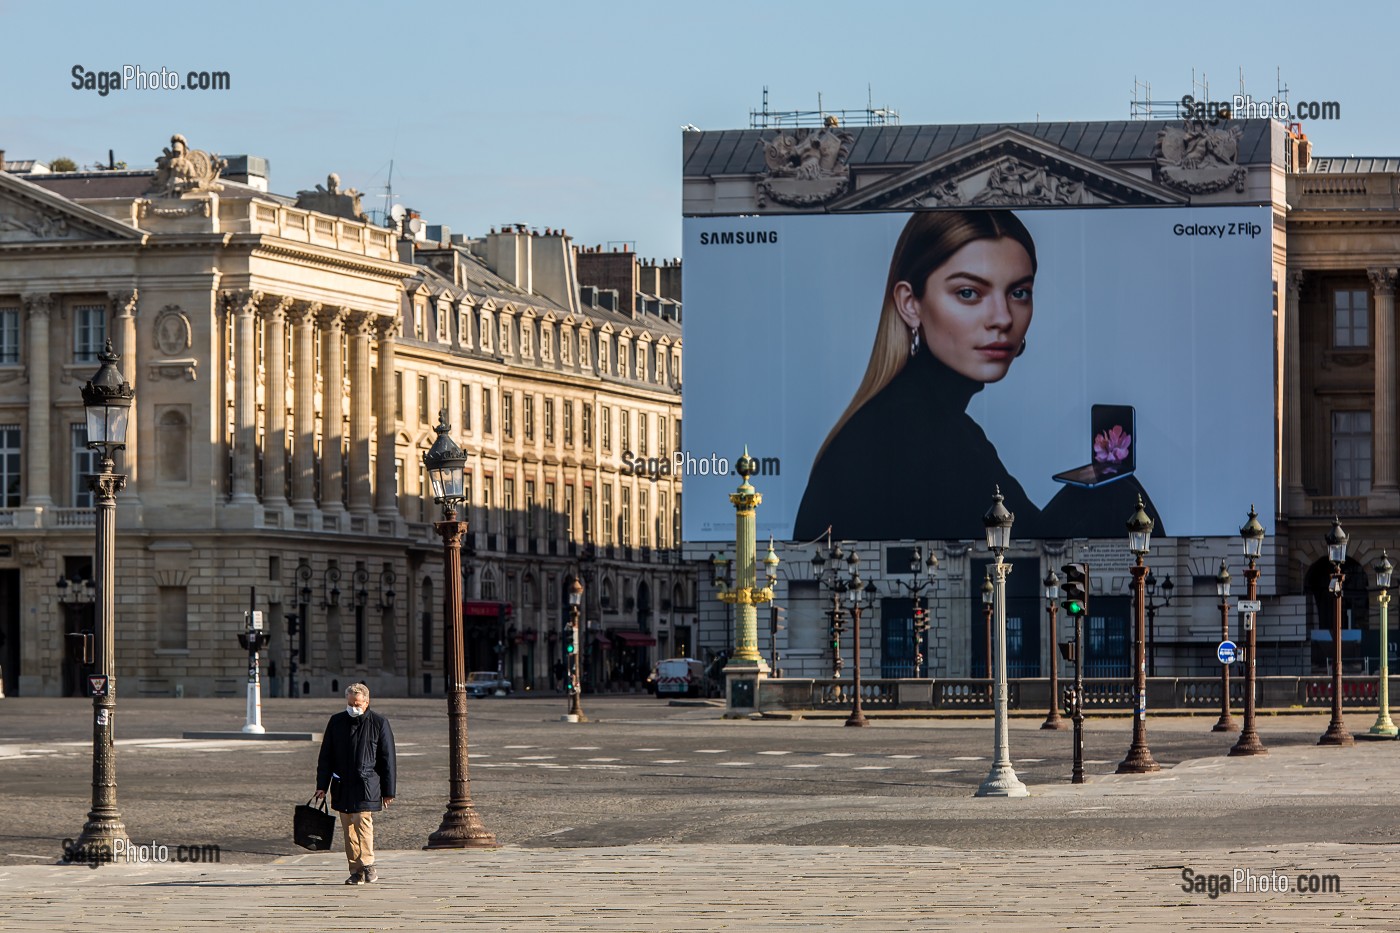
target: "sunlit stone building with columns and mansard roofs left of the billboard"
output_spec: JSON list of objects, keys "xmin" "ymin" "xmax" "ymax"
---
[{"xmin": 0, "ymin": 136, "xmax": 683, "ymax": 696}]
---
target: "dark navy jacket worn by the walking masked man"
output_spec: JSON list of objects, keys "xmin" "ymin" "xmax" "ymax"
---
[{"xmin": 316, "ymin": 709, "xmax": 396, "ymax": 813}]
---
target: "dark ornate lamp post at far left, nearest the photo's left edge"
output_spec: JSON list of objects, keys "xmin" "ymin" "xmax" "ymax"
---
[{"xmin": 77, "ymin": 340, "xmax": 136, "ymax": 853}]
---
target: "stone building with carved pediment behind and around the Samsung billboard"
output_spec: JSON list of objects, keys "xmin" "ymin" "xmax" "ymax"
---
[{"xmin": 683, "ymin": 120, "xmax": 1400, "ymax": 677}]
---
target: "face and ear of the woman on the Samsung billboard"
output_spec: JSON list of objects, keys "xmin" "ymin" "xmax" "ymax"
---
[{"xmin": 895, "ymin": 237, "xmax": 1035, "ymax": 382}]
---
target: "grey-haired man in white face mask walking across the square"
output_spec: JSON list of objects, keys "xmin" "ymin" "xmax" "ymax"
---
[{"xmin": 316, "ymin": 684, "xmax": 396, "ymax": 884}]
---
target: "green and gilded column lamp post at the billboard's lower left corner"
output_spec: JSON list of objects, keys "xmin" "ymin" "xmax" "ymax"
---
[{"xmin": 720, "ymin": 447, "xmax": 778, "ymax": 709}]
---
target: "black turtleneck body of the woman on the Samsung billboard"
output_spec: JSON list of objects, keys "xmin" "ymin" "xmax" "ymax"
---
[{"xmin": 792, "ymin": 349, "xmax": 1040, "ymax": 541}]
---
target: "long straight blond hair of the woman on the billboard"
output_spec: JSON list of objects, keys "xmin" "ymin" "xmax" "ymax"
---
[{"xmin": 816, "ymin": 210, "xmax": 1036, "ymax": 459}]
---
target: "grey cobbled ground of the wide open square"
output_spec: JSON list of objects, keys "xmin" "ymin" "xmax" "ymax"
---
[{"xmin": 0, "ymin": 698, "xmax": 1400, "ymax": 932}]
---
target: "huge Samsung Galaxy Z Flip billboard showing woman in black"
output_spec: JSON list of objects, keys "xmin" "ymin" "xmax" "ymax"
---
[{"xmin": 683, "ymin": 206, "xmax": 1274, "ymax": 541}]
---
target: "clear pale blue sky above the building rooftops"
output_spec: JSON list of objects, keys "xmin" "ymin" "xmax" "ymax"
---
[{"xmin": 0, "ymin": 0, "xmax": 1400, "ymax": 258}]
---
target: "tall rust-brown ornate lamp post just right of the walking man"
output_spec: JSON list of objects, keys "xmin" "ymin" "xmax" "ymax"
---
[{"xmin": 423, "ymin": 409, "xmax": 496, "ymax": 849}]
